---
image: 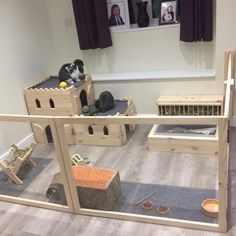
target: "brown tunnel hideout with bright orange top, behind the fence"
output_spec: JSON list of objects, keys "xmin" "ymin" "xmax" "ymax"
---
[{"xmin": 46, "ymin": 164, "xmax": 121, "ymax": 210}]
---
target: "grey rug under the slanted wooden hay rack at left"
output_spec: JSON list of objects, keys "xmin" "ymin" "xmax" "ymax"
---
[{"xmin": 0, "ymin": 157, "xmax": 51, "ymax": 196}]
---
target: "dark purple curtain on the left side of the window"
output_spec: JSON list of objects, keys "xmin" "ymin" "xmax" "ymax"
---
[{"xmin": 72, "ymin": 0, "xmax": 112, "ymax": 50}]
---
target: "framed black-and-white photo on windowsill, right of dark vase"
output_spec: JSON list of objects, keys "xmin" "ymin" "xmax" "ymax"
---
[{"xmin": 159, "ymin": 1, "xmax": 177, "ymax": 25}]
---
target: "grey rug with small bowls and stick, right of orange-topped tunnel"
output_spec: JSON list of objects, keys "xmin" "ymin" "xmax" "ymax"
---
[{"xmin": 115, "ymin": 182, "xmax": 217, "ymax": 223}]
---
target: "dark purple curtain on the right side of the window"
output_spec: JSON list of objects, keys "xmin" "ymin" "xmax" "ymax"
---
[{"xmin": 180, "ymin": 0, "xmax": 213, "ymax": 42}]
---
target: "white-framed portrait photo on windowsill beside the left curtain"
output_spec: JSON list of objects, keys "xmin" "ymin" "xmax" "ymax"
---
[{"xmin": 107, "ymin": 0, "xmax": 130, "ymax": 31}]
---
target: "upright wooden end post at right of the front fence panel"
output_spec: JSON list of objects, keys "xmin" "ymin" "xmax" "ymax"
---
[{"xmin": 218, "ymin": 118, "xmax": 229, "ymax": 232}]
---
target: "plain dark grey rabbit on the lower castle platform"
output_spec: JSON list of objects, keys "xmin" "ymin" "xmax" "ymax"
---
[{"xmin": 95, "ymin": 91, "xmax": 115, "ymax": 112}]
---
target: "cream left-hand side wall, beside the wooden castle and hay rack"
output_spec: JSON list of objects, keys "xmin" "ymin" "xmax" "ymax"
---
[{"xmin": 0, "ymin": 0, "xmax": 55, "ymax": 151}]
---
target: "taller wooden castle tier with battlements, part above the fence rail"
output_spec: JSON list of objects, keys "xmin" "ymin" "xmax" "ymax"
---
[{"xmin": 24, "ymin": 75, "xmax": 94, "ymax": 116}]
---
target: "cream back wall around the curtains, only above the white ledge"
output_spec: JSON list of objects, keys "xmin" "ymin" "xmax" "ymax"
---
[{"xmin": 47, "ymin": 0, "xmax": 215, "ymax": 73}]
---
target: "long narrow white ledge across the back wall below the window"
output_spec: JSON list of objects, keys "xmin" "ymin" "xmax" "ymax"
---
[{"xmin": 92, "ymin": 69, "xmax": 215, "ymax": 82}]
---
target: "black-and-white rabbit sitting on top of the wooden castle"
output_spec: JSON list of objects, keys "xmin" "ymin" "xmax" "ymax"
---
[{"xmin": 58, "ymin": 59, "xmax": 85, "ymax": 85}]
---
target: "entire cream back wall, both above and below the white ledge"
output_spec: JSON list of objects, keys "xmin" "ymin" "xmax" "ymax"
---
[{"xmin": 47, "ymin": 0, "xmax": 219, "ymax": 113}]
